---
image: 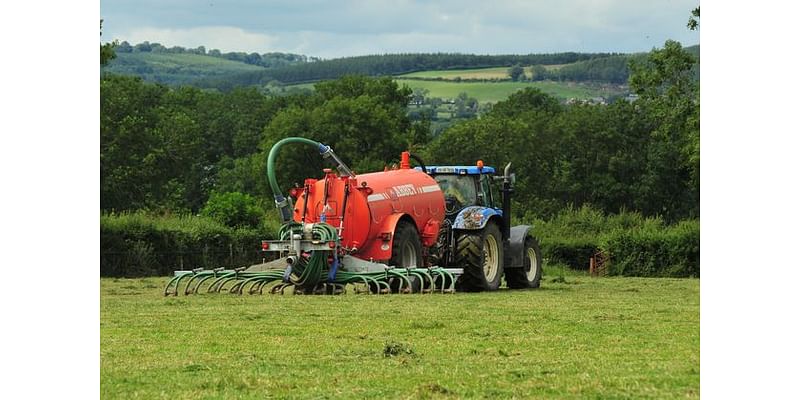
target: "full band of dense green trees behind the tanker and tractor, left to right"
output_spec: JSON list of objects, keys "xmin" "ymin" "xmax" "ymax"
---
[{"xmin": 100, "ymin": 41, "xmax": 699, "ymax": 221}]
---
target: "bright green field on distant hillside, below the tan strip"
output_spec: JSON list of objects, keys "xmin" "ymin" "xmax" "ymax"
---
[{"xmin": 397, "ymin": 79, "xmax": 617, "ymax": 103}]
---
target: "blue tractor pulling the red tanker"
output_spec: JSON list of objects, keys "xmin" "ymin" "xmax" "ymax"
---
[{"xmin": 412, "ymin": 162, "xmax": 542, "ymax": 291}]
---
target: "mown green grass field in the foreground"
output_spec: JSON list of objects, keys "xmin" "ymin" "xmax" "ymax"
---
[{"xmin": 100, "ymin": 276, "xmax": 700, "ymax": 399}]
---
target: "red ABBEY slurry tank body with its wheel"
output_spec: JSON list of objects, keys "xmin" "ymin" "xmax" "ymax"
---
[{"xmin": 291, "ymin": 152, "xmax": 445, "ymax": 267}]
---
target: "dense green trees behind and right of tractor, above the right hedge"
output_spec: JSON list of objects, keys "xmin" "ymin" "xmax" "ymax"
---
[{"xmin": 425, "ymin": 41, "xmax": 700, "ymax": 221}]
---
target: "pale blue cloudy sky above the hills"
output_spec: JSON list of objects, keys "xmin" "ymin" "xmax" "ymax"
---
[{"xmin": 100, "ymin": 0, "xmax": 700, "ymax": 59}]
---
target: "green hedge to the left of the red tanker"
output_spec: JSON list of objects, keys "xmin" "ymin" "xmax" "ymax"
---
[{"xmin": 100, "ymin": 213, "xmax": 275, "ymax": 277}]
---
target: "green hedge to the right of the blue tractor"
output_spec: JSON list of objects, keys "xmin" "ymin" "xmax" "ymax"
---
[{"xmin": 523, "ymin": 206, "xmax": 700, "ymax": 277}]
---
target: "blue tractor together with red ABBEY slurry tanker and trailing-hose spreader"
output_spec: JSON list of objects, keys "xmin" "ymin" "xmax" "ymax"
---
[{"xmin": 164, "ymin": 138, "xmax": 542, "ymax": 295}]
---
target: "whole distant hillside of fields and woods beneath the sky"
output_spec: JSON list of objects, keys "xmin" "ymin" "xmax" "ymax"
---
[{"xmin": 102, "ymin": 45, "xmax": 700, "ymax": 103}]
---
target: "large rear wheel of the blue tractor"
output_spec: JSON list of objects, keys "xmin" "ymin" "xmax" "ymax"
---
[{"xmin": 455, "ymin": 223, "xmax": 503, "ymax": 292}]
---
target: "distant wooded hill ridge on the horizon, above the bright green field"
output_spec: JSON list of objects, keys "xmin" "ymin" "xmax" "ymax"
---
[{"xmin": 102, "ymin": 42, "xmax": 700, "ymax": 91}]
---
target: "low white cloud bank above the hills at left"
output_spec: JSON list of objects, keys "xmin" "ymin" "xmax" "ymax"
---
[{"xmin": 120, "ymin": 26, "xmax": 280, "ymax": 53}]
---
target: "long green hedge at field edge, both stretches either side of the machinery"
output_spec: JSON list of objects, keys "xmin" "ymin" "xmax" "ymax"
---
[{"xmin": 100, "ymin": 207, "xmax": 700, "ymax": 277}]
